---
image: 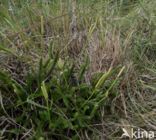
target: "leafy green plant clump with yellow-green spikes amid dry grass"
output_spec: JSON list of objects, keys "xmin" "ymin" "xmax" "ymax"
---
[{"xmin": 0, "ymin": 51, "xmax": 123, "ymax": 138}]
